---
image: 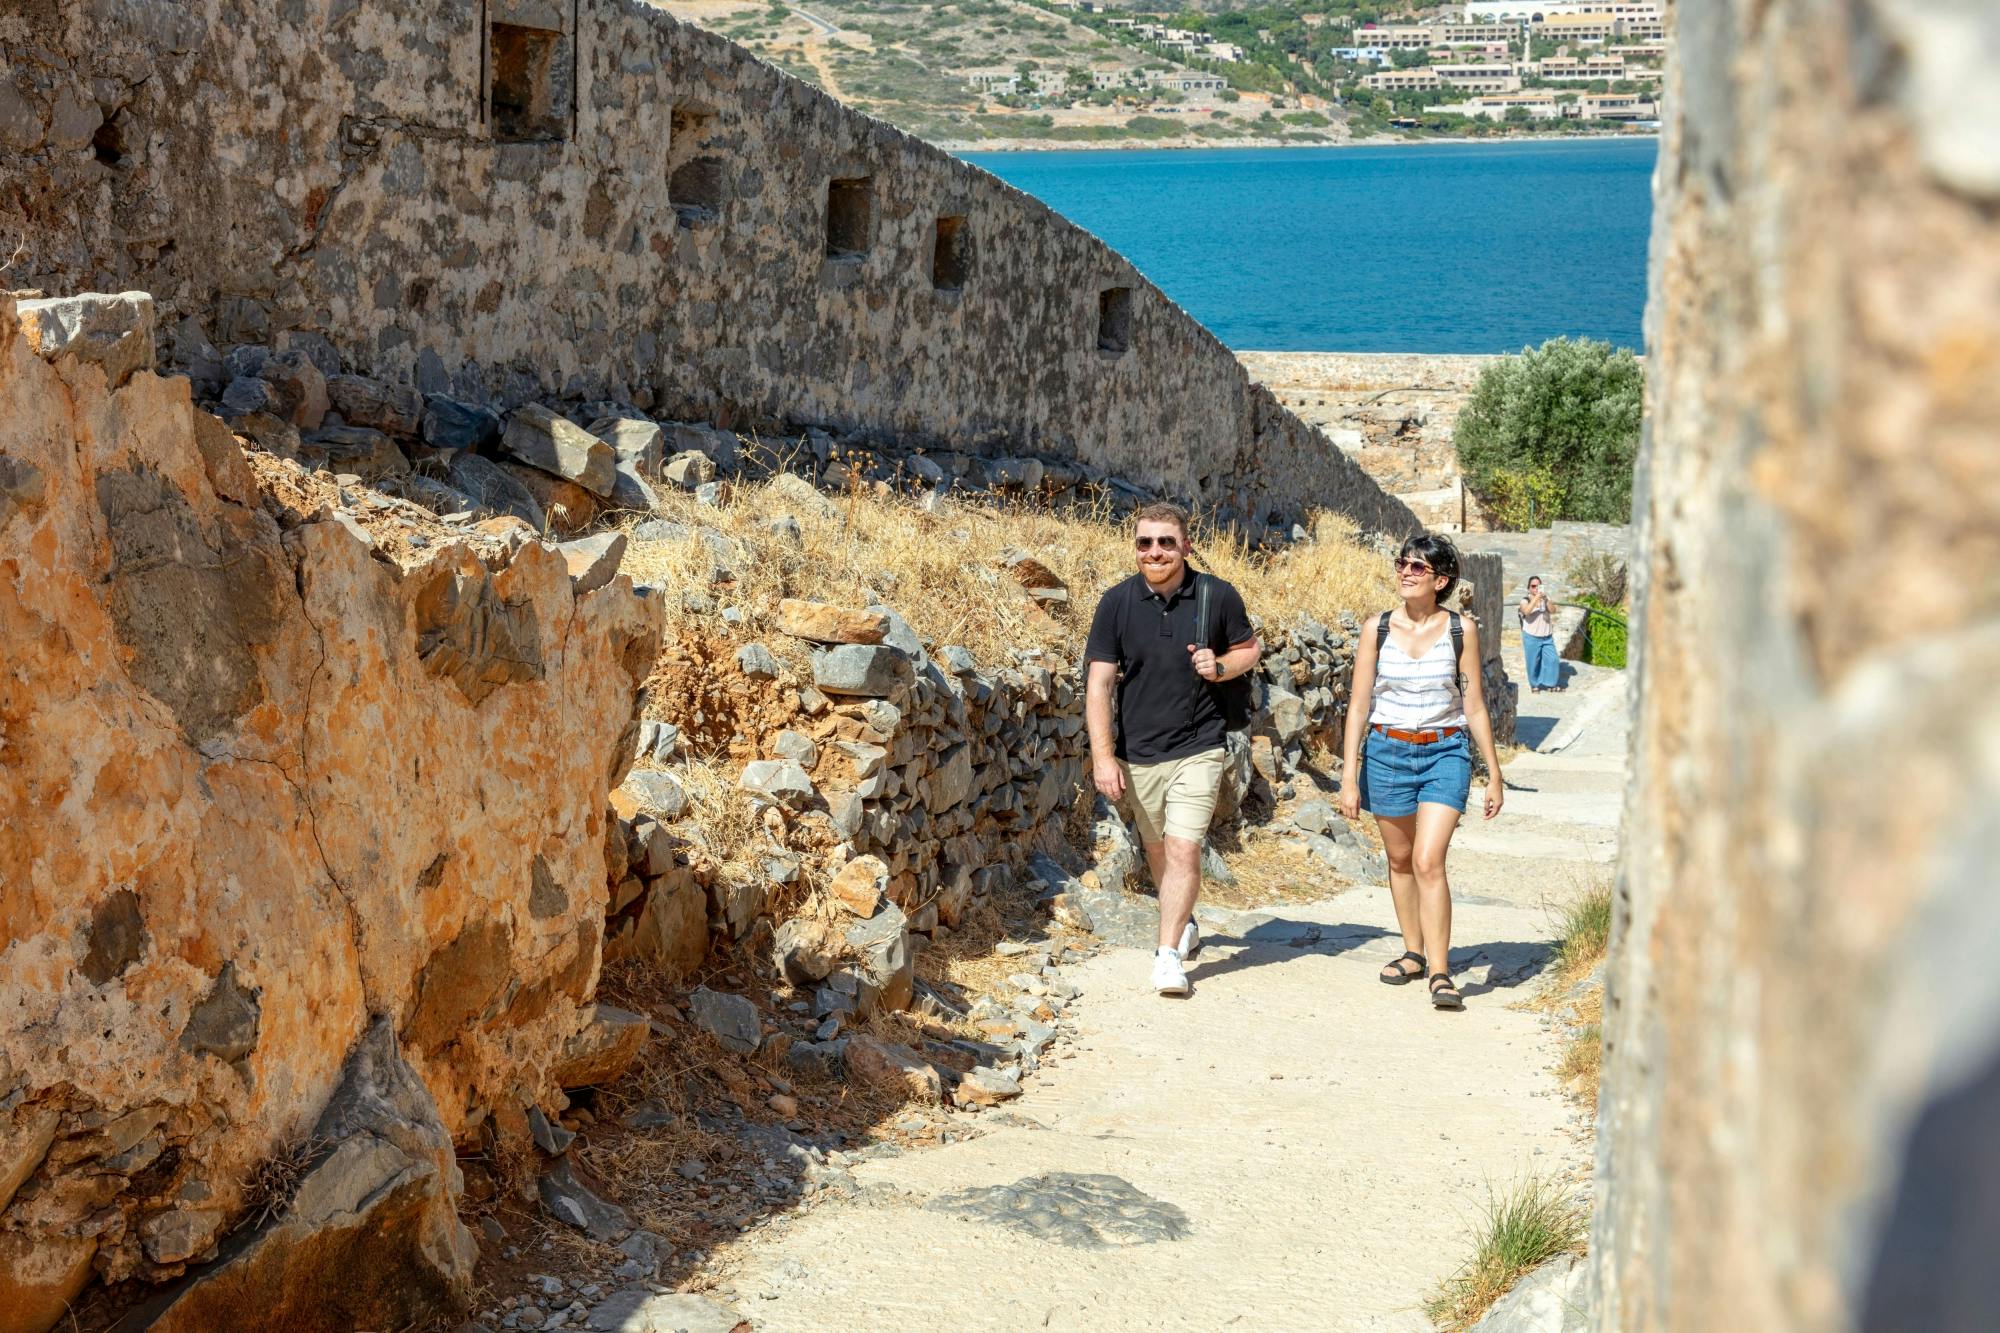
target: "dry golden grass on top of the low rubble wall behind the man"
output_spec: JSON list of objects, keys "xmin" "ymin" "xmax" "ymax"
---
[{"xmin": 624, "ymin": 470, "xmax": 1394, "ymax": 664}]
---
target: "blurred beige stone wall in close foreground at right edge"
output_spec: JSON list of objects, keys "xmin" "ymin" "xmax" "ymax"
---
[{"xmin": 1590, "ymin": 0, "xmax": 2000, "ymax": 1329}]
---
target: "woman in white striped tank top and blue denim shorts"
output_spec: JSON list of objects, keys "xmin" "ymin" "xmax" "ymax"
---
[{"xmin": 1340, "ymin": 534, "xmax": 1506, "ymax": 1009}]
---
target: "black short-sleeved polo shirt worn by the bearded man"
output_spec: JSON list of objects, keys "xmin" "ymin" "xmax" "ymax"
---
[{"xmin": 1084, "ymin": 570, "xmax": 1256, "ymax": 765}]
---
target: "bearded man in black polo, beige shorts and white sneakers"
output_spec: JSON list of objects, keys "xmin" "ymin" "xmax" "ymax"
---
[{"xmin": 1084, "ymin": 504, "xmax": 1262, "ymax": 995}]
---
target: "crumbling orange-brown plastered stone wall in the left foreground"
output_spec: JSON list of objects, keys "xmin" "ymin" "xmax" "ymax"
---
[{"xmin": 0, "ymin": 292, "xmax": 660, "ymax": 1329}]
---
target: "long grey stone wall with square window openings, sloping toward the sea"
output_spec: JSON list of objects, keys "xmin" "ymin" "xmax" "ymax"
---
[{"xmin": 0, "ymin": 0, "xmax": 1416, "ymax": 534}]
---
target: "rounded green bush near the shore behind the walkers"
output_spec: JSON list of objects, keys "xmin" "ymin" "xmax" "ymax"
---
[{"xmin": 1452, "ymin": 338, "xmax": 1644, "ymax": 526}]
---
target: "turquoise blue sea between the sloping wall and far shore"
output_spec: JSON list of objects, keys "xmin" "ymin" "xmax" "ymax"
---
[{"xmin": 964, "ymin": 138, "xmax": 1658, "ymax": 352}]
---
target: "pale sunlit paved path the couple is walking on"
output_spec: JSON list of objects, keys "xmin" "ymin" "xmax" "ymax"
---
[{"xmin": 688, "ymin": 669, "xmax": 1624, "ymax": 1333}]
